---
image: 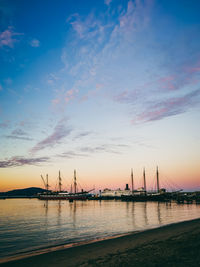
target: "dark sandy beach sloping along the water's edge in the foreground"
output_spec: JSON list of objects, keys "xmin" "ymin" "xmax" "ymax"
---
[{"xmin": 1, "ymin": 219, "xmax": 200, "ymax": 267}]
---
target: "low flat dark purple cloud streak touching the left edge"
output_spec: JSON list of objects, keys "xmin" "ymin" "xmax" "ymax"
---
[{"xmin": 0, "ymin": 157, "xmax": 50, "ymax": 168}]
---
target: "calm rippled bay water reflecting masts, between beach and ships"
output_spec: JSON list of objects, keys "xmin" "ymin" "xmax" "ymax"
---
[{"xmin": 0, "ymin": 199, "xmax": 200, "ymax": 258}]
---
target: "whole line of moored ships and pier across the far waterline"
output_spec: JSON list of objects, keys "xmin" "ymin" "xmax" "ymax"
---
[{"xmin": 37, "ymin": 167, "xmax": 200, "ymax": 204}]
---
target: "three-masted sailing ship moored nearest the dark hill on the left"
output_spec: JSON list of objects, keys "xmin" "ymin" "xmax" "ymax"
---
[{"xmin": 38, "ymin": 170, "xmax": 93, "ymax": 201}]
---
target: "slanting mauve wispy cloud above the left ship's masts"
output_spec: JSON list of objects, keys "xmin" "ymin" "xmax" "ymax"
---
[{"xmin": 31, "ymin": 119, "xmax": 72, "ymax": 153}]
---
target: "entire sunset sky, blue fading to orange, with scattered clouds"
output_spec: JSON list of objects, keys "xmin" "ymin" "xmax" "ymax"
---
[{"xmin": 0, "ymin": 0, "xmax": 200, "ymax": 191}]
